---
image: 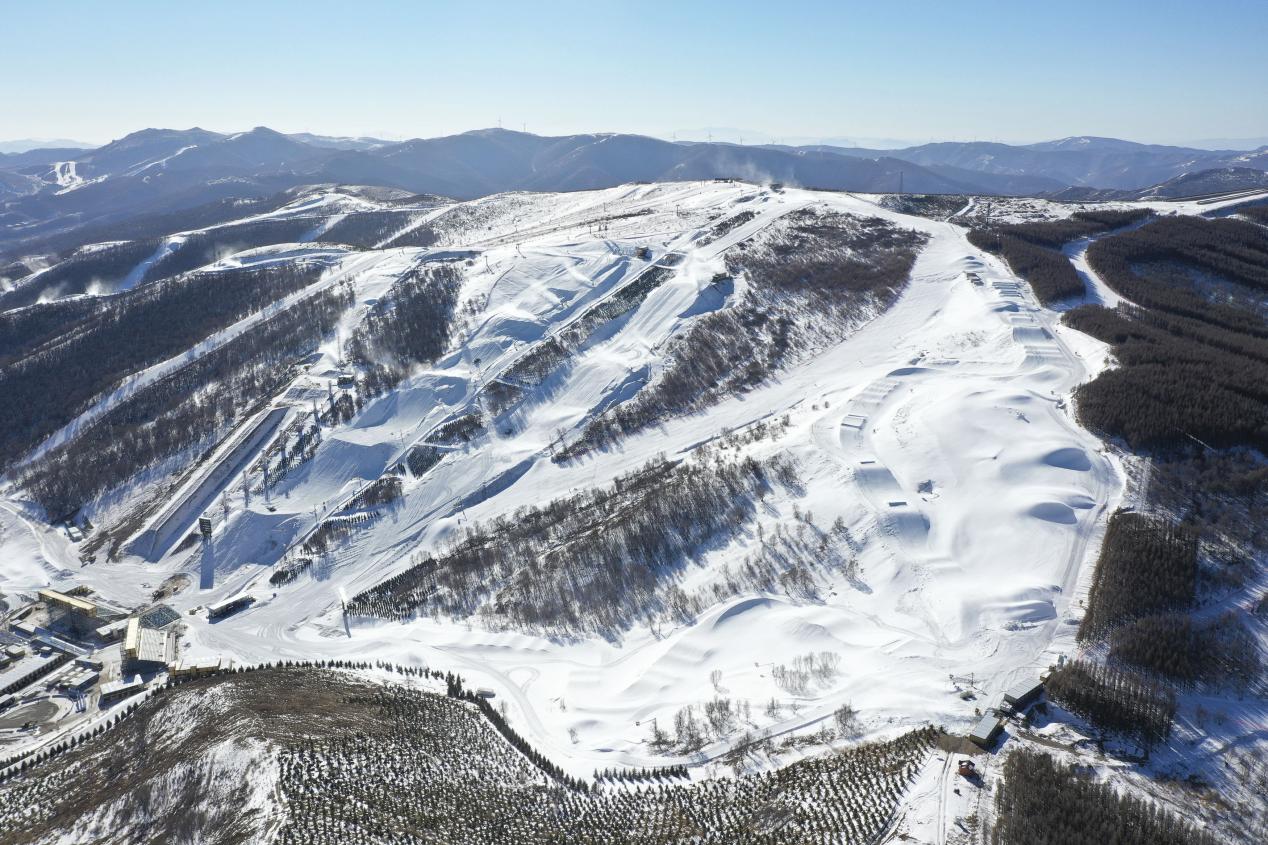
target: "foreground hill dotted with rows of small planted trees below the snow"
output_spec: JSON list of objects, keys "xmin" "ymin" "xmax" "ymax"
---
[{"xmin": 0, "ymin": 660, "xmax": 938, "ymax": 845}]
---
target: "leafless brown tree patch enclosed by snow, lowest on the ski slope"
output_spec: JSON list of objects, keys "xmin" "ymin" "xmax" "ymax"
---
[{"xmin": 345, "ymin": 458, "xmax": 796, "ymax": 634}]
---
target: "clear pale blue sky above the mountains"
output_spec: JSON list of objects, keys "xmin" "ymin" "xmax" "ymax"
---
[{"xmin": 0, "ymin": 0, "xmax": 1268, "ymax": 142}]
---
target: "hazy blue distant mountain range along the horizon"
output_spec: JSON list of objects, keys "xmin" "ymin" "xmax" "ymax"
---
[{"xmin": 0, "ymin": 127, "xmax": 1268, "ymax": 249}]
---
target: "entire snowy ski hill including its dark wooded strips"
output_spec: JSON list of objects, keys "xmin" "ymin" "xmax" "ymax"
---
[{"xmin": 0, "ymin": 173, "xmax": 1268, "ymax": 841}]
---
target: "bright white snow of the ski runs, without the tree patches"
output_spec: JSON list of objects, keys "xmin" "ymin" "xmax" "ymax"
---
[{"xmin": 6, "ymin": 183, "xmax": 1141, "ymax": 773}]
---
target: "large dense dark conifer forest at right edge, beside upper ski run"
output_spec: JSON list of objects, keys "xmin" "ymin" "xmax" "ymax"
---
[{"xmin": 1065, "ymin": 217, "xmax": 1268, "ymax": 450}]
